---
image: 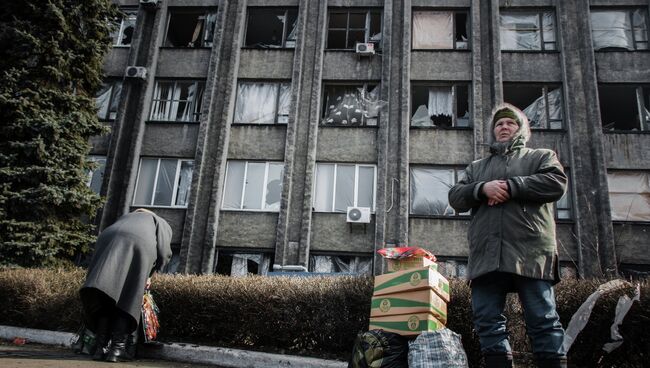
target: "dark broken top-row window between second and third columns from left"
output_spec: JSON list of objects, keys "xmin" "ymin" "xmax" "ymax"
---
[{"xmin": 244, "ymin": 8, "xmax": 298, "ymax": 48}]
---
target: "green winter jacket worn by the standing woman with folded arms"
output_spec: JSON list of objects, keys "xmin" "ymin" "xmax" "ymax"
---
[{"xmin": 449, "ymin": 140, "xmax": 567, "ymax": 282}]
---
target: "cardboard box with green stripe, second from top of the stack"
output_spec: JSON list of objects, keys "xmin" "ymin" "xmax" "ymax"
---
[{"xmin": 372, "ymin": 266, "xmax": 449, "ymax": 303}]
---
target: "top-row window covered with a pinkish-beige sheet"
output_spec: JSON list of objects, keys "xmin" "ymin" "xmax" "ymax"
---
[{"xmin": 413, "ymin": 11, "xmax": 469, "ymax": 50}]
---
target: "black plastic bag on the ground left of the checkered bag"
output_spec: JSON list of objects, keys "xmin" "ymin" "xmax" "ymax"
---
[{"xmin": 348, "ymin": 330, "xmax": 408, "ymax": 368}]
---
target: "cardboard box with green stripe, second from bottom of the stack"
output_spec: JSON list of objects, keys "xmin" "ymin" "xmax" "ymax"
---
[{"xmin": 370, "ymin": 289, "xmax": 447, "ymax": 324}]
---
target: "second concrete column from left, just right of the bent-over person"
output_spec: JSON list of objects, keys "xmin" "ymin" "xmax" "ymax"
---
[{"xmin": 179, "ymin": 0, "xmax": 247, "ymax": 274}]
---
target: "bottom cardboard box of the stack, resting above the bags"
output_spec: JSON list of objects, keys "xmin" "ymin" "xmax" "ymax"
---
[{"xmin": 369, "ymin": 313, "xmax": 445, "ymax": 336}]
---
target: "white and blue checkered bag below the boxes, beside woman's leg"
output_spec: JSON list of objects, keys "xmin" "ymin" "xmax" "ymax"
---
[{"xmin": 408, "ymin": 328, "xmax": 468, "ymax": 368}]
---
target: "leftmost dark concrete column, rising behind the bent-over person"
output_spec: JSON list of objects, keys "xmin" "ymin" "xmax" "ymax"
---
[{"xmin": 99, "ymin": 7, "xmax": 167, "ymax": 231}]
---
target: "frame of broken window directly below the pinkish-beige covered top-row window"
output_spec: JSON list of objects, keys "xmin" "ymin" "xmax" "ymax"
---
[{"xmin": 409, "ymin": 81, "xmax": 474, "ymax": 130}]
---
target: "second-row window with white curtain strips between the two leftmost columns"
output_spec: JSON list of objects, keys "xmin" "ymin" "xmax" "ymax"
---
[{"xmin": 150, "ymin": 81, "xmax": 204, "ymax": 122}]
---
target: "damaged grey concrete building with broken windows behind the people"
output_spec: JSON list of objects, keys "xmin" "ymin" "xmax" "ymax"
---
[{"xmin": 90, "ymin": 0, "xmax": 650, "ymax": 277}]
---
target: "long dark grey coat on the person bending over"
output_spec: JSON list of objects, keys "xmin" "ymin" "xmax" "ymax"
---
[{"xmin": 80, "ymin": 211, "xmax": 172, "ymax": 329}]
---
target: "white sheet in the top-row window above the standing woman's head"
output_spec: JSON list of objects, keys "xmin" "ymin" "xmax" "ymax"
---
[{"xmin": 500, "ymin": 14, "xmax": 541, "ymax": 50}]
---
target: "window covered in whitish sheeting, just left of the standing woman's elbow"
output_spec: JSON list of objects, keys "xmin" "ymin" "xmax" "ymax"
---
[{"xmin": 410, "ymin": 167, "xmax": 469, "ymax": 216}]
